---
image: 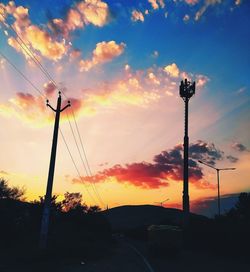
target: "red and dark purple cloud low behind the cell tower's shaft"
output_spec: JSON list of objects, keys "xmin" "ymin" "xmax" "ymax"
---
[{"xmin": 73, "ymin": 141, "xmax": 222, "ymax": 189}]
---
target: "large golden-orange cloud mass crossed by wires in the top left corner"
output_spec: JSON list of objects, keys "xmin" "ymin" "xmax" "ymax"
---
[{"xmin": 0, "ymin": 0, "xmax": 109, "ymax": 61}]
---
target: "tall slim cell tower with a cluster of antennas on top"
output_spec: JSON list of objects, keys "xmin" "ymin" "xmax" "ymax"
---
[{"xmin": 180, "ymin": 79, "xmax": 195, "ymax": 226}]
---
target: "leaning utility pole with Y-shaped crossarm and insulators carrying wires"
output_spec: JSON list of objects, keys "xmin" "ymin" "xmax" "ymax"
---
[{"xmin": 39, "ymin": 92, "xmax": 70, "ymax": 250}]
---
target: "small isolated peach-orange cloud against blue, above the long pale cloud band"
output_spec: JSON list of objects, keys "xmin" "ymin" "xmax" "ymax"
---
[{"xmin": 79, "ymin": 41, "xmax": 126, "ymax": 72}]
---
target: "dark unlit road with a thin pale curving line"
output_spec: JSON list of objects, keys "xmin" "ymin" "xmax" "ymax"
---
[{"xmin": 0, "ymin": 237, "xmax": 250, "ymax": 272}]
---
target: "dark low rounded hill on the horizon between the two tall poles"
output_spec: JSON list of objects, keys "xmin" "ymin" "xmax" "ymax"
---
[{"xmin": 103, "ymin": 205, "xmax": 206, "ymax": 230}]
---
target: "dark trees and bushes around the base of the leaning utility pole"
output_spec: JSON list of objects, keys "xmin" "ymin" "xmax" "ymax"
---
[{"xmin": 0, "ymin": 179, "xmax": 111, "ymax": 272}]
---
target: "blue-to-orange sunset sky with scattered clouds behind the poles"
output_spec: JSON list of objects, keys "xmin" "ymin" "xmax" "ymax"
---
[{"xmin": 0, "ymin": 0, "xmax": 250, "ymax": 217}]
